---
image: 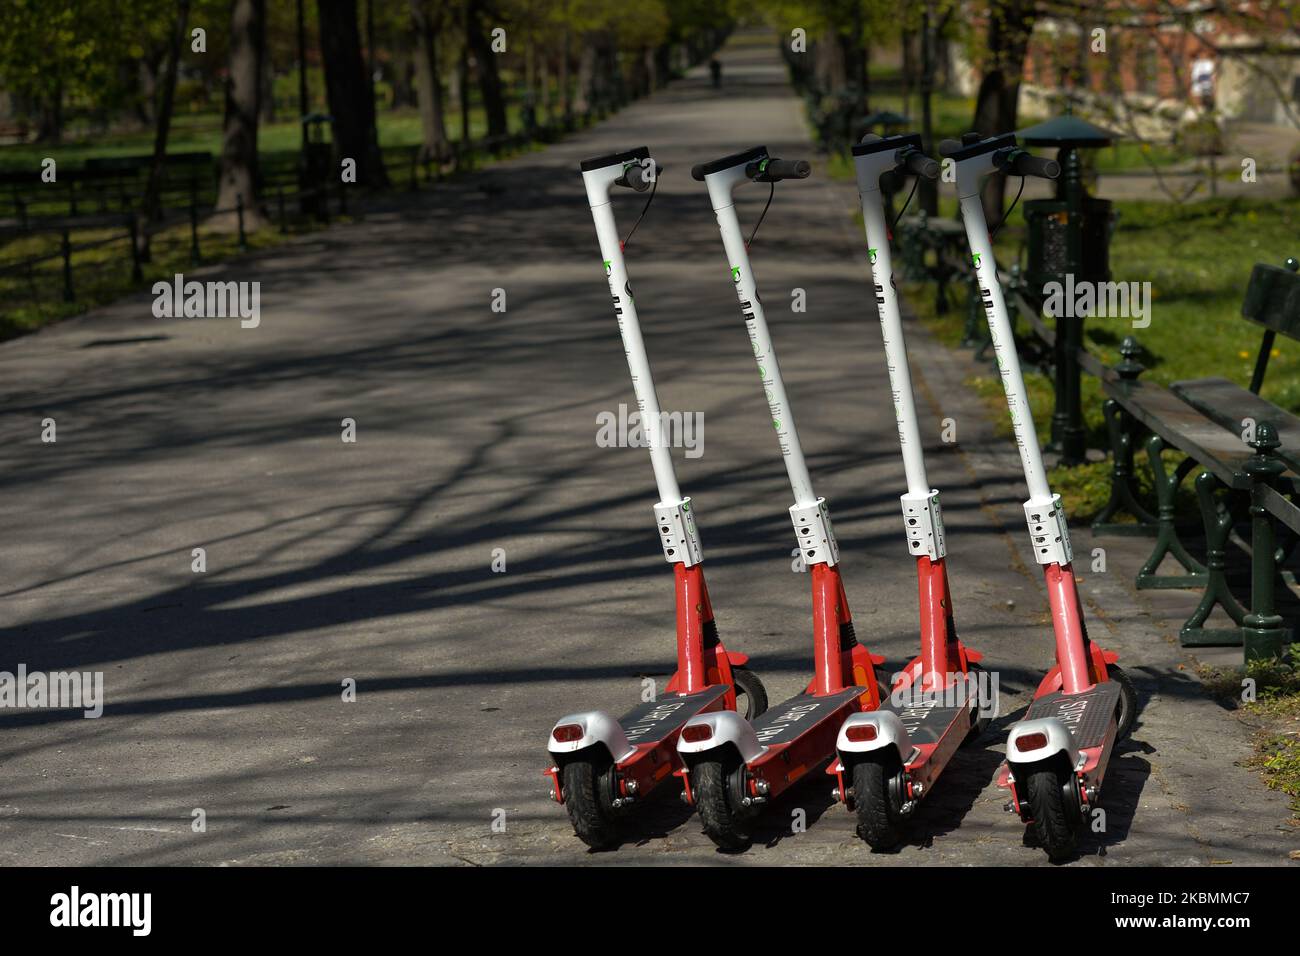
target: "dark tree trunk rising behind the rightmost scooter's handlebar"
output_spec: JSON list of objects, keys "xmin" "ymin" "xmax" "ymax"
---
[{"xmin": 975, "ymin": 0, "xmax": 1035, "ymax": 226}]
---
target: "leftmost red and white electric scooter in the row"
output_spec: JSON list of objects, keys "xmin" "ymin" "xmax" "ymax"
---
[{"xmin": 546, "ymin": 147, "xmax": 767, "ymax": 848}]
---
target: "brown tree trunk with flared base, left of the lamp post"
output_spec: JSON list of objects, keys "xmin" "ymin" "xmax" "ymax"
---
[{"xmin": 215, "ymin": 0, "xmax": 267, "ymax": 232}]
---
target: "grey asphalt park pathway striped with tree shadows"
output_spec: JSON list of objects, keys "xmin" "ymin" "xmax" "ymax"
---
[{"xmin": 0, "ymin": 34, "xmax": 1294, "ymax": 865}]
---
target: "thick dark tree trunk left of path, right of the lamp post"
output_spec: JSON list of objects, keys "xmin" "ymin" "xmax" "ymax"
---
[{"xmin": 316, "ymin": 0, "xmax": 389, "ymax": 187}]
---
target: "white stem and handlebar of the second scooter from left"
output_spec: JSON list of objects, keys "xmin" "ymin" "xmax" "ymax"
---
[{"xmin": 694, "ymin": 147, "xmax": 839, "ymax": 567}]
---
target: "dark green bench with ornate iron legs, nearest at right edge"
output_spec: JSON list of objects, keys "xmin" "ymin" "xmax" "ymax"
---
[{"xmin": 1093, "ymin": 260, "xmax": 1300, "ymax": 659}]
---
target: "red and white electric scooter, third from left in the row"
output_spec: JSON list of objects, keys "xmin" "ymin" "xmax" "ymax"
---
[{"xmin": 827, "ymin": 133, "xmax": 987, "ymax": 849}]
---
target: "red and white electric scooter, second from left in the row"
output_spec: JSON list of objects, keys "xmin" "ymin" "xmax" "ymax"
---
[{"xmin": 677, "ymin": 147, "xmax": 884, "ymax": 849}]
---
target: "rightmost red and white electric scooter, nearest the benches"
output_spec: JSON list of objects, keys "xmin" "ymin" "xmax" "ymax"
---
[{"xmin": 939, "ymin": 133, "xmax": 1138, "ymax": 861}]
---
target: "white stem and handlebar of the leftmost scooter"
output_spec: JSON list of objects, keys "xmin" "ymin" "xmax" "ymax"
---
[{"xmin": 582, "ymin": 147, "xmax": 703, "ymax": 567}]
